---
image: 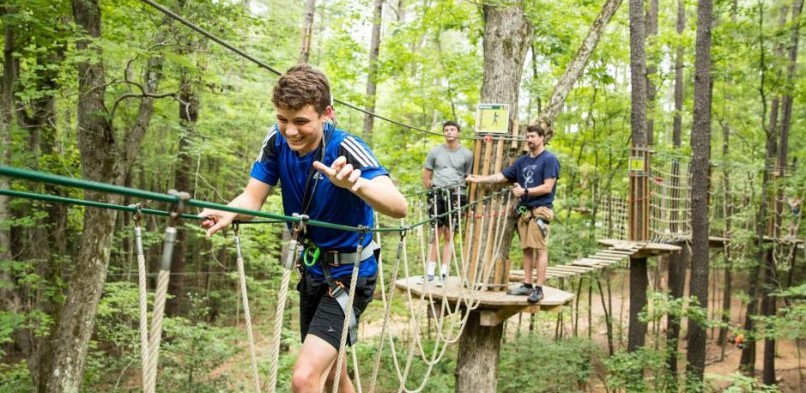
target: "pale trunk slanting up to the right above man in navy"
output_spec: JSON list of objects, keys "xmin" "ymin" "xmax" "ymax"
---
[{"xmin": 541, "ymin": 0, "xmax": 622, "ymax": 124}]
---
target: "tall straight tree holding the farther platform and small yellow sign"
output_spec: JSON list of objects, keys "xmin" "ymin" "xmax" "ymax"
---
[{"xmin": 627, "ymin": 0, "xmax": 649, "ymax": 352}]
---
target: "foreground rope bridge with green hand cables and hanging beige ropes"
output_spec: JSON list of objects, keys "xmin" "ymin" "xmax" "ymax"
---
[{"xmin": 0, "ymin": 166, "xmax": 528, "ymax": 393}]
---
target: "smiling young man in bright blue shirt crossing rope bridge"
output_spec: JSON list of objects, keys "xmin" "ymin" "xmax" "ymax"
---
[{"xmin": 199, "ymin": 65, "xmax": 408, "ymax": 392}]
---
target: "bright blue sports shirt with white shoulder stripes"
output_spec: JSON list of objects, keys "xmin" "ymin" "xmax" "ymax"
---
[{"xmin": 251, "ymin": 124, "xmax": 389, "ymax": 278}]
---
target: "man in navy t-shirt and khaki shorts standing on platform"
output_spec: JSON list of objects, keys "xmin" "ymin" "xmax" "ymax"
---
[{"xmin": 467, "ymin": 122, "xmax": 560, "ymax": 303}]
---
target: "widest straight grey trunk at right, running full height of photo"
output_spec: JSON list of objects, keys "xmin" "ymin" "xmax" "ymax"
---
[{"xmin": 686, "ymin": 0, "xmax": 713, "ymax": 391}]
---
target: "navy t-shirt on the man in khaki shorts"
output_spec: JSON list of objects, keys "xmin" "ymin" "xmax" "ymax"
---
[{"xmin": 501, "ymin": 150, "xmax": 560, "ymax": 208}]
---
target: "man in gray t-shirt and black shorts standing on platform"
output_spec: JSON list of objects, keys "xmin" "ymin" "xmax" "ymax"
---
[{"xmin": 423, "ymin": 121, "xmax": 473, "ymax": 285}]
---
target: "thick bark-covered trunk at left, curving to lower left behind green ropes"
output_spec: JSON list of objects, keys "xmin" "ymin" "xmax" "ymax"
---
[{"xmin": 39, "ymin": 0, "xmax": 122, "ymax": 392}]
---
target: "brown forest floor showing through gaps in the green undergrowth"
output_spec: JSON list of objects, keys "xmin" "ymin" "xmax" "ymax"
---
[{"xmin": 207, "ymin": 269, "xmax": 806, "ymax": 393}]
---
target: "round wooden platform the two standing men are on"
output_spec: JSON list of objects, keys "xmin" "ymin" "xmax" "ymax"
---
[{"xmin": 395, "ymin": 276, "xmax": 574, "ymax": 326}]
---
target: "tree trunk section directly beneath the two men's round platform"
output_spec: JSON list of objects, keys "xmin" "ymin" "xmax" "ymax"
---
[{"xmin": 455, "ymin": 311, "xmax": 504, "ymax": 393}]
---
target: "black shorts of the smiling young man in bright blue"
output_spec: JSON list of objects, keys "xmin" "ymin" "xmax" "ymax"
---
[{"xmin": 297, "ymin": 275, "xmax": 377, "ymax": 350}]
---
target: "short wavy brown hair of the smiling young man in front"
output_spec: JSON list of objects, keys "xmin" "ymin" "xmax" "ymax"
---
[{"xmin": 271, "ymin": 64, "xmax": 331, "ymax": 115}]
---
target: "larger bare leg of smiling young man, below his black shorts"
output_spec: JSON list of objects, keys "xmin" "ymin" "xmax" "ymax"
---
[{"xmin": 291, "ymin": 334, "xmax": 338, "ymax": 393}]
